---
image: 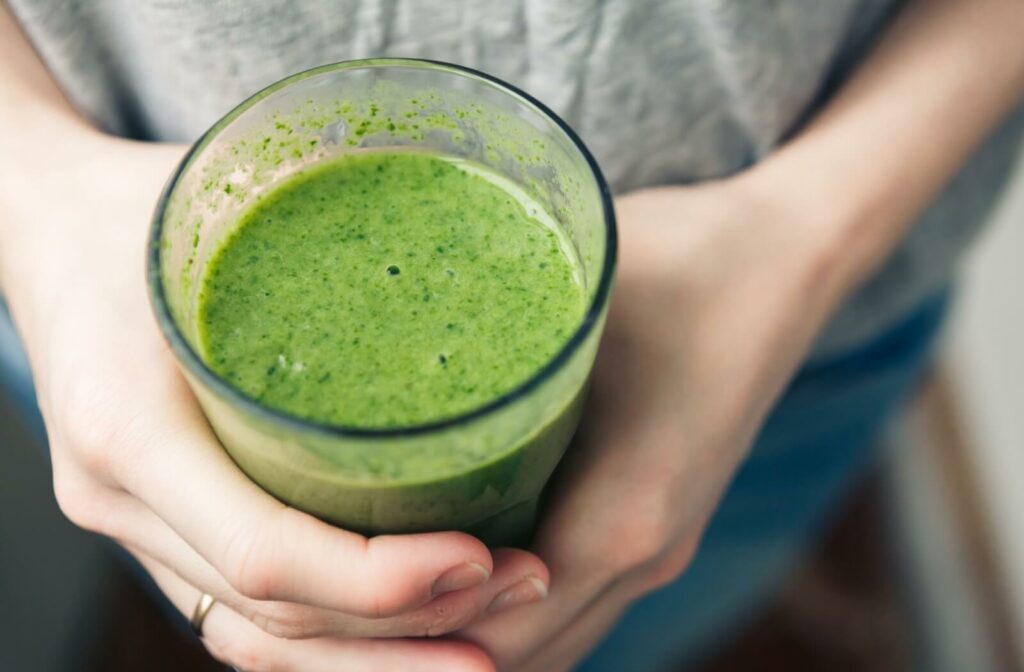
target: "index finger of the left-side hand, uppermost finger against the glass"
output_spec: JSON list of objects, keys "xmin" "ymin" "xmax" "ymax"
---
[{"xmin": 114, "ymin": 353, "xmax": 507, "ymax": 618}]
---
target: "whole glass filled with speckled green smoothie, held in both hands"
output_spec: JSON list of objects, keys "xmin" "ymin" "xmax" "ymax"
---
[{"xmin": 147, "ymin": 58, "xmax": 615, "ymax": 546}]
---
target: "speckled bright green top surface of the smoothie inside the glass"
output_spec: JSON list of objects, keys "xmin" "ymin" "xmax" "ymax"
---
[{"xmin": 199, "ymin": 152, "xmax": 585, "ymax": 428}]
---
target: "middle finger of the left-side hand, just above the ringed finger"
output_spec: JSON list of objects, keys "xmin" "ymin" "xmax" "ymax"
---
[{"xmin": 116, "ymin": 495, "xmax": 549, "ymax": 638}]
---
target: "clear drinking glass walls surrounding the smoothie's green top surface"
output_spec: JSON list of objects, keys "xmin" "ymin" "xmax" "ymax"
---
[{"xmin": 147, "ymin": 58, "xmax": 615, "ymax": 546}]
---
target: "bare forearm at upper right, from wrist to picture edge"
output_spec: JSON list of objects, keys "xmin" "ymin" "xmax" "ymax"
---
[{"xmin": 750, "ymin": 0, "xmax": 1024, "ymax": 310}]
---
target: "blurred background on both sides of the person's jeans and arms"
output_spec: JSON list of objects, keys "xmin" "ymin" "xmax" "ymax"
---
[{"xmin": 0, "ymin": 155, "xmax": 1024, "ymax": 672}]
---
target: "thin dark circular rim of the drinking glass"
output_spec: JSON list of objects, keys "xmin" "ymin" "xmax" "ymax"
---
[{"xmin": 146, "ymin": 57, "xmax": 618, "ymax": 438}]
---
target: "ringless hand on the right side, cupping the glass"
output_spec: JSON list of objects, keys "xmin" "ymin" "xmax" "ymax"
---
[{"xmin": 459, "ymin": 171, "xmax": 838, "ymax": 672}]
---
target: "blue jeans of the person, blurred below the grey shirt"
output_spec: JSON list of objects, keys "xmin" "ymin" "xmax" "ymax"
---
[{"xmin": 0, "ymin": 292, "xmax": 948, "ymax": 672}]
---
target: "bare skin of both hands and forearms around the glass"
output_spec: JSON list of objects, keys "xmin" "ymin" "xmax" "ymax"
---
[{"xmin": 0, "ymin": 0, "xmax": 1024, "ymax": 672}]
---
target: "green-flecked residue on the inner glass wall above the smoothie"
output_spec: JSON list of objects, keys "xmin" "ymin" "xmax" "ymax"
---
[{"xmin": 165, "ymin": 76, "xmax": 582, "ymax": 346}]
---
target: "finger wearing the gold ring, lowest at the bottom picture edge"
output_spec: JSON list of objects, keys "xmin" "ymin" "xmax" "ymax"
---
[{"xmin": 136, "ymin": 554, "xmax": 495, "ymax": 672}]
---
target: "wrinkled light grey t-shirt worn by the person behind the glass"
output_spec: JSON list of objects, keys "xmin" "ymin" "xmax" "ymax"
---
[{"xmin": 8, "ymin": 0, "xmax": 1024, "ymax": 356}]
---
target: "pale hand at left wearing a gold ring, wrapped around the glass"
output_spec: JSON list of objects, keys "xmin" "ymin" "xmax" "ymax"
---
[{"xmin": 0, "ymin": 132, "xmax": 549, "ymax": 672}]
